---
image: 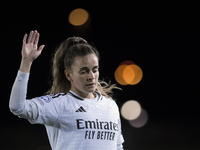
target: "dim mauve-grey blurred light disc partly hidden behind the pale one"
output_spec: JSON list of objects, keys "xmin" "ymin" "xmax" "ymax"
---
[{"xmin": 129, "ymin": 109, "xmax": 148, "ymax": 128}]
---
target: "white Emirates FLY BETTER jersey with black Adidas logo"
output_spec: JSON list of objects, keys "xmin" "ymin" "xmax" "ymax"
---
[{"xmin": 10, "ymin": 70, "xmax": 124, "ymax": 150}]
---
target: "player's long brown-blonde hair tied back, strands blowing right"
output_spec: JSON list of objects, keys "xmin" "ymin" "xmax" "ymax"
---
[{"xmin": 47, "ymin": 37, "xmax": 120, "ymax": 99}]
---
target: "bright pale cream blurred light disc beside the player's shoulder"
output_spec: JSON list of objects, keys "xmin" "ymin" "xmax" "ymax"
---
[{"xmin": 121, "ymin": 100, "xmax": 141, "ymax": 120}]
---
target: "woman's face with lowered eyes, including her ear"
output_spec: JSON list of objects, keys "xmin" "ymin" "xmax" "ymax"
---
[{"xmin": 65, "ymin": 54, "xmax": 99, "ymax": 98}]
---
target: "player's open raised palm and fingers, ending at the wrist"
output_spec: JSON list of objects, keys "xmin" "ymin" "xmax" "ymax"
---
[{"xmin": 22, "ymin": 30, "xmax": 44, "ymax": 61}]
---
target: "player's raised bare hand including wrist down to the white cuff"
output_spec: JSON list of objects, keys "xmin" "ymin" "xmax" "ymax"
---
[{"xmin": 19, "ymin": 30, "xmax": 44, "ymax": 73}]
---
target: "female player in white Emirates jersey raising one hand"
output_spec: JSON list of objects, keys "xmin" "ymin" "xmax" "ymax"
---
[{"xmin": 9, "ymin": 31, "xmax": 124, "ymax": 150}]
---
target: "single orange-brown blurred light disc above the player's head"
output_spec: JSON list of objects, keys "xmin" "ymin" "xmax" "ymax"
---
[{"xmin": 69, "ymin": 8, "xmax": 89, "ymax": 26}]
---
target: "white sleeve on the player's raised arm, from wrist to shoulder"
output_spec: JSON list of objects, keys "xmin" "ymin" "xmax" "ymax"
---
[{"xmin": 9, "ymin": 71, "xmax": 59, "ymax": 125}]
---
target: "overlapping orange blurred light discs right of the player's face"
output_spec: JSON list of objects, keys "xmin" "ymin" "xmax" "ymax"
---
[{"xmin": 114, "ymin": 60, "xmax": 143, "ymax": 85}]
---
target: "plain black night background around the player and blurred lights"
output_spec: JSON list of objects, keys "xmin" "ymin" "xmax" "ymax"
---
[{"xmin": 0, "ymin": 0, "xmax": 200, "ymax": 150}]
